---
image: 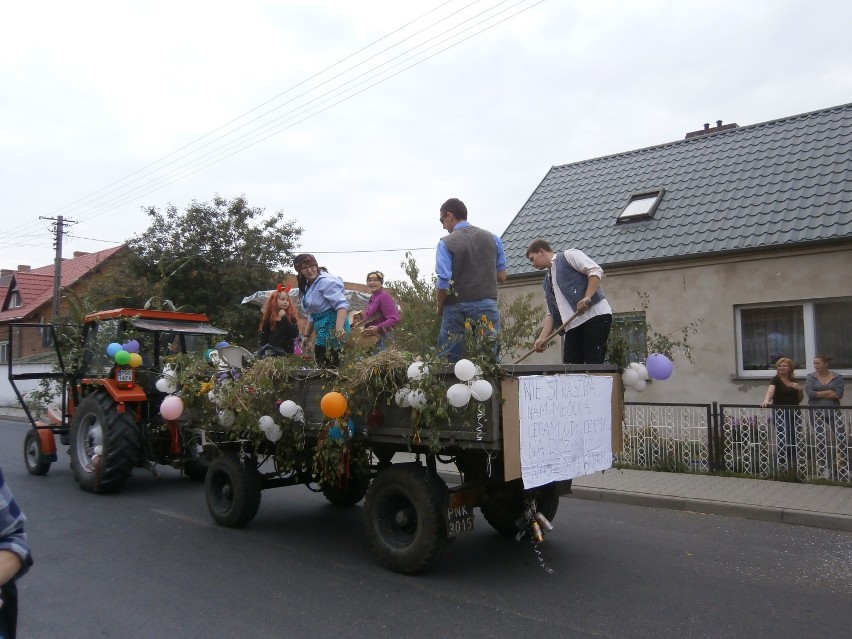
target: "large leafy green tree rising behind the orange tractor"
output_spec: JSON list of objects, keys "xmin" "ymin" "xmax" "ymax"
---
[{"xmin": 128, "ymin": 195, "xmax": 302, "ymax": 350}]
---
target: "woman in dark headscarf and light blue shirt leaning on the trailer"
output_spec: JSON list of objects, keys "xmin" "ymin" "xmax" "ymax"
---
[{"xmin": 293, "ymin": 253, "xmax": 349, "ymax": 367}]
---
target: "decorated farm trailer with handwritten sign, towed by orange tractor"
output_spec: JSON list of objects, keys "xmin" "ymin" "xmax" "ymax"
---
[{"xmin": 205, "ymin": 365, "xmax": 623, "ymax": 574}]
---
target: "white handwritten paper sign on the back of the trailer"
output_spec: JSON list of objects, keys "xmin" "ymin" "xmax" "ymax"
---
[{"xmin": 518, "ymin": 375, "xmax": 612, "ymax": 488}]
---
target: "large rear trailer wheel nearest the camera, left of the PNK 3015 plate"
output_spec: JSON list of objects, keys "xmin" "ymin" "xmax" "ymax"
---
[{"xmin": 364, "ymin": 464, "xmax": 447, "ymax": 574}]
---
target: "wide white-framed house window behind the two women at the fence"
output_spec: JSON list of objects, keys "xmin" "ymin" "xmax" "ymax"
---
[{"xmin": 735, "ymin": 298, "xmax": 852, "ymax": 377}]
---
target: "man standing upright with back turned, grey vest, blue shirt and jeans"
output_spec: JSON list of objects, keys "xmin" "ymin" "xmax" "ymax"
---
[{"xmin": 435, "ymin": 198, "xmax": 506, "ymax": 362}]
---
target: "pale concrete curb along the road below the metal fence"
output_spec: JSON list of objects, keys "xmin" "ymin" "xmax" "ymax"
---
[{"xmin": 571, "ymin": 486, "xmax": 852, "ymax": 532}]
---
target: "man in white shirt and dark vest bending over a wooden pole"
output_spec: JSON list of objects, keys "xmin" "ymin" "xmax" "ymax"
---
[{"xmin": 527, "ymin": 240, "xmax": 612, "ymax": 364}]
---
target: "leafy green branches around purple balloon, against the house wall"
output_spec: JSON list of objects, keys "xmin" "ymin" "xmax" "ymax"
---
[{"xmin": 607, "ymin": 291, "xmax": 704, "ymax": 368}]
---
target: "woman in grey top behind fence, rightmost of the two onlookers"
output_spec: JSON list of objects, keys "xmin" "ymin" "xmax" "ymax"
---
[{"xmin": 806, "ymin": 355, "xmax": 850, "ymax": 481}]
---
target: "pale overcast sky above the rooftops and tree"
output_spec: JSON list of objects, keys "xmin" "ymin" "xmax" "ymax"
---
[{"xmin": 0, "ymin": 0, "xmax": 852, "ymax": 290}]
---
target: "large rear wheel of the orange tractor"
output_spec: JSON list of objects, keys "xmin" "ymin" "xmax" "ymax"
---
[{"xmin": 68, "ymin": 391, "xmax": 141, "ymax": 493}]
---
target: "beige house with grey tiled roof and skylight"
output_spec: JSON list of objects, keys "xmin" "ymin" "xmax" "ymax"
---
[{"xmin": 501, "ymin": 104, "xmax": 852, "ymax": 405}]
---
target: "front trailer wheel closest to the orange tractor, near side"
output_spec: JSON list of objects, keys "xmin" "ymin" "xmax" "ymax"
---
[{"xmin": 204, "ymin": 455, "xmax": 261, "ymax": 528}]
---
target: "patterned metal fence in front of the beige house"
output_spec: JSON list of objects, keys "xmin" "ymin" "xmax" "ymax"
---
[{"xmin": 615, "ymin": 402, "xmax": 852, "ymax": 483}]
